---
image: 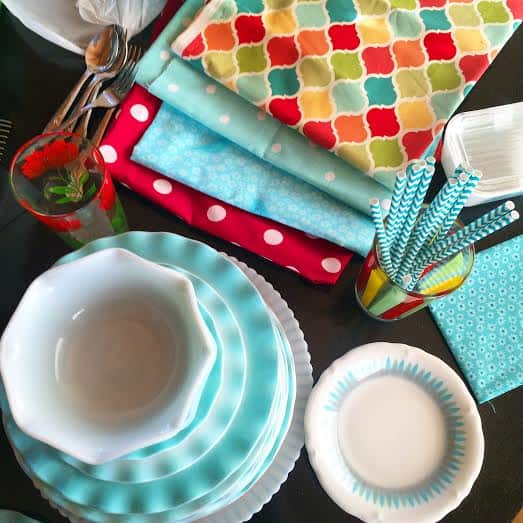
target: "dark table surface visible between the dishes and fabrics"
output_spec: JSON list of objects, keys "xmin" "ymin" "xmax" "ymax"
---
[{"xmin": 0, "ymin": 9, "xmax": 523, "ymax": 523}]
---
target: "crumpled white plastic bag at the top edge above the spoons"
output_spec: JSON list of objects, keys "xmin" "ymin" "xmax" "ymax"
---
[{"xmin": 76, "ymin": 0, "xmax": 166, "ymax": 37}]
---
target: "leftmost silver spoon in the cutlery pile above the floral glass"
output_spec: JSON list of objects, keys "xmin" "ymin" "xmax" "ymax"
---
[{"xmin": 44, "ymin": 26, "xmax": 119, "ymax": 133}]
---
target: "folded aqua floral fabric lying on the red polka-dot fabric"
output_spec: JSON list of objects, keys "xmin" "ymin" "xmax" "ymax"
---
[{"xmin": 132, "ymin": 103, "xmax": 374, "ymax": 255}]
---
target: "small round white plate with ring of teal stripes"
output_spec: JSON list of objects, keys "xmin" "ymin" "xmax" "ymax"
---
[{"xmin": 305, "ymin": 342, "xmax": 484, "ymax": 523}]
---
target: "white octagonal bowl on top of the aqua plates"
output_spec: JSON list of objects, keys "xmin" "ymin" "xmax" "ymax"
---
[{"xmin": 0, "ymin": 249, "xmax": 216, "ymax": 464}]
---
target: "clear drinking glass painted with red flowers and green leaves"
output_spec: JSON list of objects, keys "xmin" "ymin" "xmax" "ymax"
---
[{"xmin": 11, "ymin": 132, "xmax": 127, "ymax": 248}]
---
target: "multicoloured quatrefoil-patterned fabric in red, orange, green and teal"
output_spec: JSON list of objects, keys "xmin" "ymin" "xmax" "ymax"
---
[{"xmin": 172, "ymin": 0, "xmax": 523, "ymax": 182}]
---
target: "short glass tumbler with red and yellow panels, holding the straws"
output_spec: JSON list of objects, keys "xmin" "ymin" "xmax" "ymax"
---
[{"xmin": 355, "ymin": 220, "xmax": 474, "ymax": 321}]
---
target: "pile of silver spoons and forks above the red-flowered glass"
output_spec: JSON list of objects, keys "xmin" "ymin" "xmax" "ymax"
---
[{"xmin": 44, "ymin": 25, "xmax": 142, "ymax": 145}]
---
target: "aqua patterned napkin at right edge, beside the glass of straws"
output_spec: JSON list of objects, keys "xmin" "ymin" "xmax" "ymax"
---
[{"xmin": 430, "ymin": 235, "xmax": 523, "ymax": 403}]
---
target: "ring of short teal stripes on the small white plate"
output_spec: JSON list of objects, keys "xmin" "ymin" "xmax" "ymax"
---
[{"xmin": 323, "ymin": 357, "xmax": 467, "ymax": 509}]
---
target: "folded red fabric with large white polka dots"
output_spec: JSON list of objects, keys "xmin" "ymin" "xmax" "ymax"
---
[{"xmin": 100, "ymin": 85, "xmax": 352, "ymax": 285}]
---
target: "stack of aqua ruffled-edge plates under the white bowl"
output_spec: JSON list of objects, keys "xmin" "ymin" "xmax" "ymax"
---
[{"xmin": 2, "ymin": 232, "xmax": 312, "ymax": 523}]
